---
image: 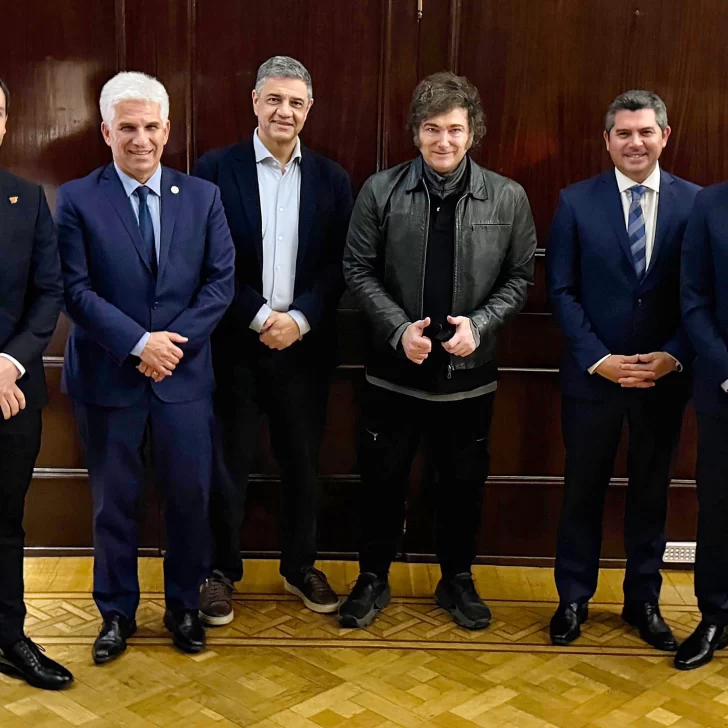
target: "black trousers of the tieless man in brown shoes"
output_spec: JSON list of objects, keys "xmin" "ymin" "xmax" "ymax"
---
[{"xmin": 210, "ymin": 344, "xmax": 330, "ymax": 582}]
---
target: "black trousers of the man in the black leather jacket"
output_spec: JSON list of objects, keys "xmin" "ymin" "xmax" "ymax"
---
[{"xmin": 359, "ymin": 384, "xmax": 494, "ymax": 578}]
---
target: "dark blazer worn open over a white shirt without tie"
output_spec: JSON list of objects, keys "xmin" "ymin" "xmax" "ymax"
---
[{"xmin": 192, "ymin": 138, "xmax": 353, "ymax": 363}]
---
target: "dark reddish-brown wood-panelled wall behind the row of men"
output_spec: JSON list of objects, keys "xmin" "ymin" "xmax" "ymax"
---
[{"xmin": 0, "ymin": 0, "xmax": 716, "ymax": 561}]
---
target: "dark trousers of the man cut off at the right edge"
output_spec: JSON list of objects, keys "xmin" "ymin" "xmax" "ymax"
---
[{"xmin": 695, "ymin": 412, "xmax": 728, "ymax": 625}]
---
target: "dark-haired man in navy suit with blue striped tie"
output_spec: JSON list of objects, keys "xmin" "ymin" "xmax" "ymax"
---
[{"xmin": 547, "ymin": 90, "xmax": 699, "ymax": 650}]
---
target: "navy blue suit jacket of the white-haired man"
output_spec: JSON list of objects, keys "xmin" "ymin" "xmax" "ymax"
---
[{"xmin": 56, "ymin": 164, "xmax": 235, "ymax": 407}]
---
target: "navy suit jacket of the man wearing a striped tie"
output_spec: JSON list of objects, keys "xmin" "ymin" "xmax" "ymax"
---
[{"xmin": 546, "ymin": 169, "xmax": 700, "ymax": 400}]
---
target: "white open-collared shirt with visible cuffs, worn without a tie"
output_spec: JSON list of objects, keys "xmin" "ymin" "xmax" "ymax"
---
[{"xmin": 250, "ymin": 129, "xmax": 311, "ymax": 336}]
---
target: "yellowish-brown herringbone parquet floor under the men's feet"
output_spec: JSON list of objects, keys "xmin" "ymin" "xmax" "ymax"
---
[{"xmin": 0, "ymin": 559, "xmax": 728, "ymax": 728}]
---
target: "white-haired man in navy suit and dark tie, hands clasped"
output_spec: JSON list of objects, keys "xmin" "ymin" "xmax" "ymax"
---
[{"xmin": 57, "ymin": 73, "xmax": 235, "ymax": 664}]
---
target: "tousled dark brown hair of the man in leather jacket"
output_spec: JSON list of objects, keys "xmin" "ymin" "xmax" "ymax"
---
[{"xmin": 407, "ymin": 71, "xmax": 485, "ymax": 146}]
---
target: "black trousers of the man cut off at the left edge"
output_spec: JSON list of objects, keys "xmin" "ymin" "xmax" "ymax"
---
[{"xmin": 0, "ymin": 409, "xmax": 41, "ymax": 648}]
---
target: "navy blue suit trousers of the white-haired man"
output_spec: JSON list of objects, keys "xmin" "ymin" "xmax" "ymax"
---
[{"xmin": 73, "ymin": 388, "xmax": 213, "ymax": 619}]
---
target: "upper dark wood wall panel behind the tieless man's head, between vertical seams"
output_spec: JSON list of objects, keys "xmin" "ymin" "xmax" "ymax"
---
[{"xmin": 194, "ymin": 0, "xmax": 386, "ymax": 187}]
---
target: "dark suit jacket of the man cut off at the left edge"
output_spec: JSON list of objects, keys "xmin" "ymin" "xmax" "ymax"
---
[{"xmin": 0, "ymin": 170, "xmax": 63, "ymax": 408}]
